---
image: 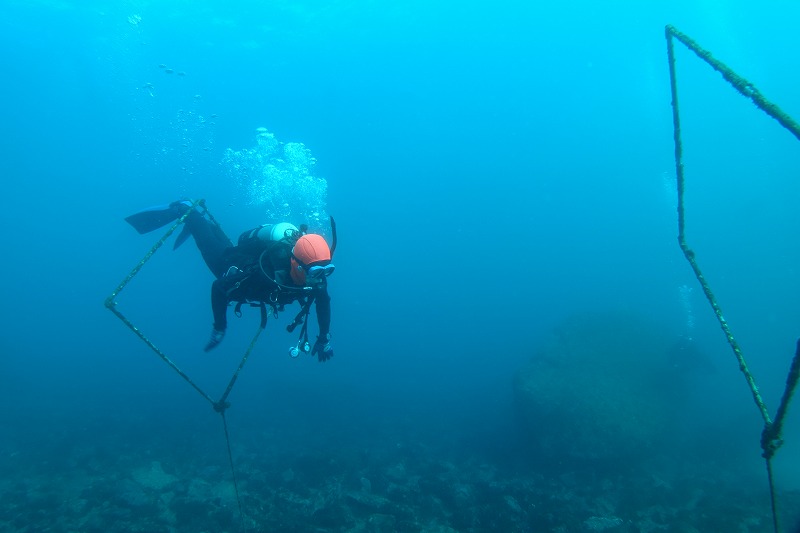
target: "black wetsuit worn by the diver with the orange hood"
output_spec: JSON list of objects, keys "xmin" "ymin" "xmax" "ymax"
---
[{"xmin": 185, "ymin": 212, "xmax": 331, "ymax": 337}]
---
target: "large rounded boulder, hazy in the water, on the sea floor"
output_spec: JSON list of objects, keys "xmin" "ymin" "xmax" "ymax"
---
[{"xmin": 514, "ymin": 313, "xmax": 687, "ymax": 460}]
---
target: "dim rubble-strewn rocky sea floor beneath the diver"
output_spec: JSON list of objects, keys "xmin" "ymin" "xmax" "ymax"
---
[{"xmin": 0, "ymin": 430, "xmax": 800, "ymax": 533}]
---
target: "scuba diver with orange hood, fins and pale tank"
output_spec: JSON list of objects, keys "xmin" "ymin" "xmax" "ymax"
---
[{"xmin": 125, "ymin": 200, "xmax": 336, "ymax": 362}]
